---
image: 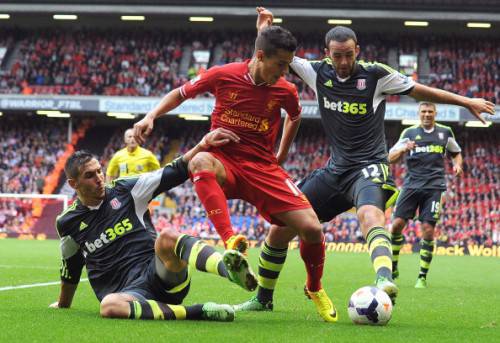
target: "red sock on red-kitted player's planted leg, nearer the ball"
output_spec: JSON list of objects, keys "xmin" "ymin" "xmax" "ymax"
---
[{"xmin": 300, "ymin": 237, "xmax": 325, "ymax": 292}]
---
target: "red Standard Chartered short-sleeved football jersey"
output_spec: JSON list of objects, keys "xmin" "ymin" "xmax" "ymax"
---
[{"xmin": 180, "ymin": 61, "xmax": 301, "ymax": 163}]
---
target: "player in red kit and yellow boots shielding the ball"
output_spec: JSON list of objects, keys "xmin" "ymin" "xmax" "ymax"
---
[{"xmin": 134, "ymin": 26, "xmax": 337, "ymax": 322}]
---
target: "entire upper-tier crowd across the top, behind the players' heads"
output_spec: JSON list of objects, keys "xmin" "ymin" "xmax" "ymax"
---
[{"xmin": 0, "ymin": 29, "xmax": 500, "ymax": 102}]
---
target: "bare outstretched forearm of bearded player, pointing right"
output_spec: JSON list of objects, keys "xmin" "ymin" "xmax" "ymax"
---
[{"xmin": 408, "ymin": 83, "xmax": 495, "ymax": 123}]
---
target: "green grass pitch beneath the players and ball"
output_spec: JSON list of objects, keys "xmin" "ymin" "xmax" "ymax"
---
[{"xmin": 0, "ymin": 239, "xmax": 500, "ymax": 342}]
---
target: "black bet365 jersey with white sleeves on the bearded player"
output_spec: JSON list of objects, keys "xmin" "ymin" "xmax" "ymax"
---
[{"xmin": 290, "ymin": 57, "xmax": 415, "ymax": 174}]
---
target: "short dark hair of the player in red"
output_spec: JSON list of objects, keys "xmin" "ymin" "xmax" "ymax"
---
[{"xmin": 255, "ymin": 26, "xmax": 297, "ymax": 56}]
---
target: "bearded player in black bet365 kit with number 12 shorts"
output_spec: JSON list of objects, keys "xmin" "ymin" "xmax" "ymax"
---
[{"xmin": 236, "ymin": 7, "xmax": 494, "ymax": 311}]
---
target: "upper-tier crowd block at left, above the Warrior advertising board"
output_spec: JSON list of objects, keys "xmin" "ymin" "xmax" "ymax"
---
[{"xmin": 0, "ymin": 30, "xmax": 190, "ymax": 96}]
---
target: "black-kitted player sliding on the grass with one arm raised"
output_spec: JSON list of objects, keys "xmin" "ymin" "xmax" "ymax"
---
[{"xmin": 50, "ymin": 129, "xmax": 257, "ymax": 321}]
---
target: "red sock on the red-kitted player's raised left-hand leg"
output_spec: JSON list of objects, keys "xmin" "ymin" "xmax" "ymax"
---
[{"xmin": 193, "ymin": 171, "xmax": 234, "ymax": 242}]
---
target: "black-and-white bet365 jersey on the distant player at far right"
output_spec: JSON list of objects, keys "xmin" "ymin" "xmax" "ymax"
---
[{"xmin": 391, "ymin": 123, "xmax": 461, "ymax": 190}]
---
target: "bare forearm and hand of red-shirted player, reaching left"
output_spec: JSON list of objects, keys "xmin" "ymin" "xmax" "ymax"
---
[{"xmin": 134, "ymin": 88, "xmax": 184, "ymax": 145}]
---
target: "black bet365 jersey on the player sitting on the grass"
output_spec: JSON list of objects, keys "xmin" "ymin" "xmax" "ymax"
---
[{"xmin": 56, "ymin": 158, "xmax": 188, "ymax": 300}]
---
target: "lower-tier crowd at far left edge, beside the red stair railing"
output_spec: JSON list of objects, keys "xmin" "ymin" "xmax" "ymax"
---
[{"xmin": 0, "ymin": 116, "xmax": 67, "ymax": 234}]
